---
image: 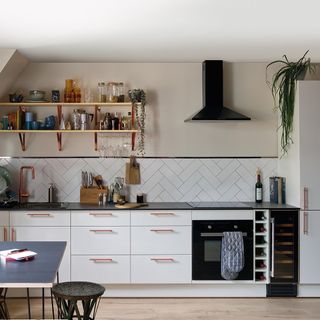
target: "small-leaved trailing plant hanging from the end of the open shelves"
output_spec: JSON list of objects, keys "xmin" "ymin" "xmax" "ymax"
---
[{"xmin": 128, "ymin": 89, "xmax": 146, "ymax": 156}]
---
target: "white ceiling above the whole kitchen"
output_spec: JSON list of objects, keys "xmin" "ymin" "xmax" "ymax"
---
[{"xmin": 0, "ymin": 0, "xmax": 320, "ymax": 62}]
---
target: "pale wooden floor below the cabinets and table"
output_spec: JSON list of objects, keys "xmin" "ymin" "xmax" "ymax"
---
[{"xmin": 7, "ymin": 298, "xmax": 320, "ymax": 320}]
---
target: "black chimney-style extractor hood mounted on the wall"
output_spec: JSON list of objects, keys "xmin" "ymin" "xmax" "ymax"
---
[{"xmin": 185, "ymin": 60, "xmax": 251, "ymax": 122}]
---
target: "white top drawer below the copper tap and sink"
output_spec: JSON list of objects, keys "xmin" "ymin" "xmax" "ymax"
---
[{"xmin": 10, "ymin": 210, "xmax": 70, "ymax": 227}]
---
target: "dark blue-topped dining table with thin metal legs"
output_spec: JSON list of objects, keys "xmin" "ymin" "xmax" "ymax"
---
[{"xmin": 0, "ymin": 241, "xmax": 67, "ymax": 319}]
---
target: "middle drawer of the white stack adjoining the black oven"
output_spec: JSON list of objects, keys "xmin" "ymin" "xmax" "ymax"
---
[{"xmin": 131, "ymin": 226, "xmax": 191, "ymax": 254}]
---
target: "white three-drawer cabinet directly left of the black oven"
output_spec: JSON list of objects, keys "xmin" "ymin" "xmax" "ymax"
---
[{"xmin": 131, "ymin": 210, "xmax": 191, "ymax": 284}]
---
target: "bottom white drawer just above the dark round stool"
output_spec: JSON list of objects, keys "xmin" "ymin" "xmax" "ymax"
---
[{"xmin": 71, "ymin": 255, "xmax": 130, "ymax": 284}]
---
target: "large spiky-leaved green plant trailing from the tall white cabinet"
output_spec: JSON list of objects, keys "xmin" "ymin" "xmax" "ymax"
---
[{"xmin": 266, "ymin": 50, "xmax": 315, "ymax": 154}]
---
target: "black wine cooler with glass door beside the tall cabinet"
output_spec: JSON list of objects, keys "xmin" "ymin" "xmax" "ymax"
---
[{"xmin": 267, "ymin": 210, "xmax": 299, "ymax": 297}]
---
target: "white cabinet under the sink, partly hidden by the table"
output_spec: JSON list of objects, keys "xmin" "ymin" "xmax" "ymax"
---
[{"xmin": 10, "ymin": 211, "xmax": 70, "ymax": 281}]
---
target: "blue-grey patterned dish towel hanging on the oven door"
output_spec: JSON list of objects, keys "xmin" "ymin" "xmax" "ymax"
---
[{"xmin": 221, "ymin": 232, "xmax": 244, "ymax": 280}]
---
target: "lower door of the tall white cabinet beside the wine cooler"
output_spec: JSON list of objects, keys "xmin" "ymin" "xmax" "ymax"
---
[{"xmin": 300, "ymin": 211, "xmax": 320, "ymax": 284}]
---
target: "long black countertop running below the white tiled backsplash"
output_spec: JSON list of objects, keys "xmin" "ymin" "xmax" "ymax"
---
[{"xmin": 0, "ymin": 201, "xmax": 298, "ymax": 211}]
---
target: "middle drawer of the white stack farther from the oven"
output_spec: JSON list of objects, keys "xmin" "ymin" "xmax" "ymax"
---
[{"xmin": 71, "ymin": 226, "xmax": 130, "ymax": 254}]
